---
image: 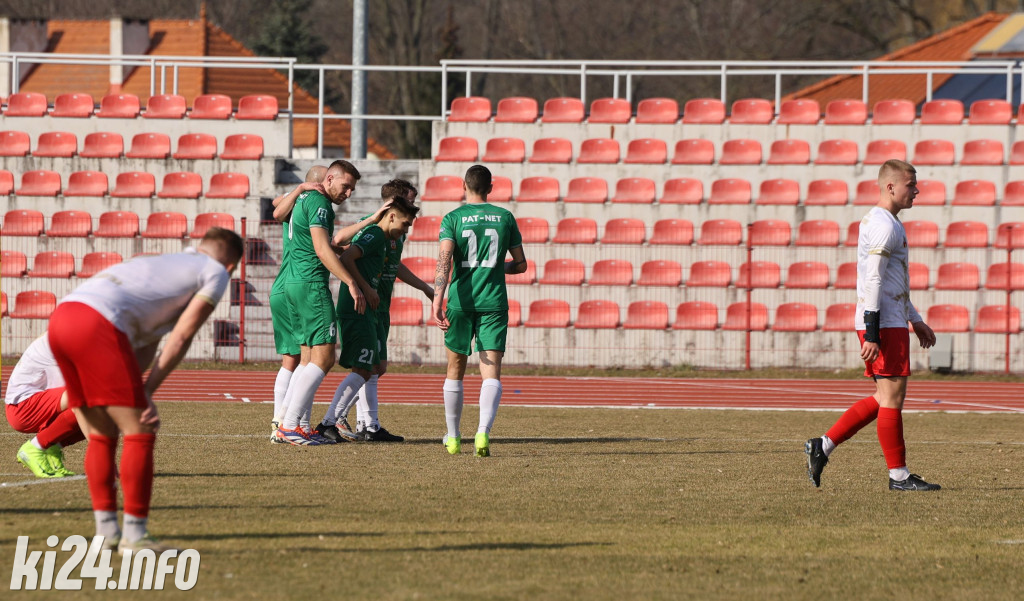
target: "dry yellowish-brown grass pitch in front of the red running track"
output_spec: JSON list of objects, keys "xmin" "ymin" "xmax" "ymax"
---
[{"xmin": 0, "ymin": 403, "xmax": 1024, "ymax": 601}]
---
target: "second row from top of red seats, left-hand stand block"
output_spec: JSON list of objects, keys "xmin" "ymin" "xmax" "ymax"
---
[{"xmin": 0, "ymin": 130, "xmax": 263, "ymax": 161}]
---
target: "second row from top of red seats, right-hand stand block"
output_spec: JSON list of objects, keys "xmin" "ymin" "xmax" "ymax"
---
[{"xmin": 434, "ymin": 136, "xmax": 1024, "ymax": 165}]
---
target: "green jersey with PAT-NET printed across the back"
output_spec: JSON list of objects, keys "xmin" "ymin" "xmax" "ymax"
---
[{"xmin": 438, "ymin": 203, "xmax": 522, "ymax": 311}]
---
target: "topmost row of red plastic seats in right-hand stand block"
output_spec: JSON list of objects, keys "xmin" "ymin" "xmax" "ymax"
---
[{"xmin": 447, "ymin": 96, "xmax": 1014, "ymax": 125}]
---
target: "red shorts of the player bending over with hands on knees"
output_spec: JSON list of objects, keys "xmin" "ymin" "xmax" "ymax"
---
[{"xmin": 48, "ymin": 302, "xmax": 147, "ymax": 409}]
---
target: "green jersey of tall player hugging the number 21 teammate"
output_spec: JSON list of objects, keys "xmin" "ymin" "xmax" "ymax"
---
[{"xmin": 285, "ymin": 190, "xmax": 334, "ymax": 282}]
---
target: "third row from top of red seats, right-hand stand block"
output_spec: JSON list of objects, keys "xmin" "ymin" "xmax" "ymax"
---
[{"xmin": 421, "ymin": 175, "xmax": 1024, "ymax": 207}]
